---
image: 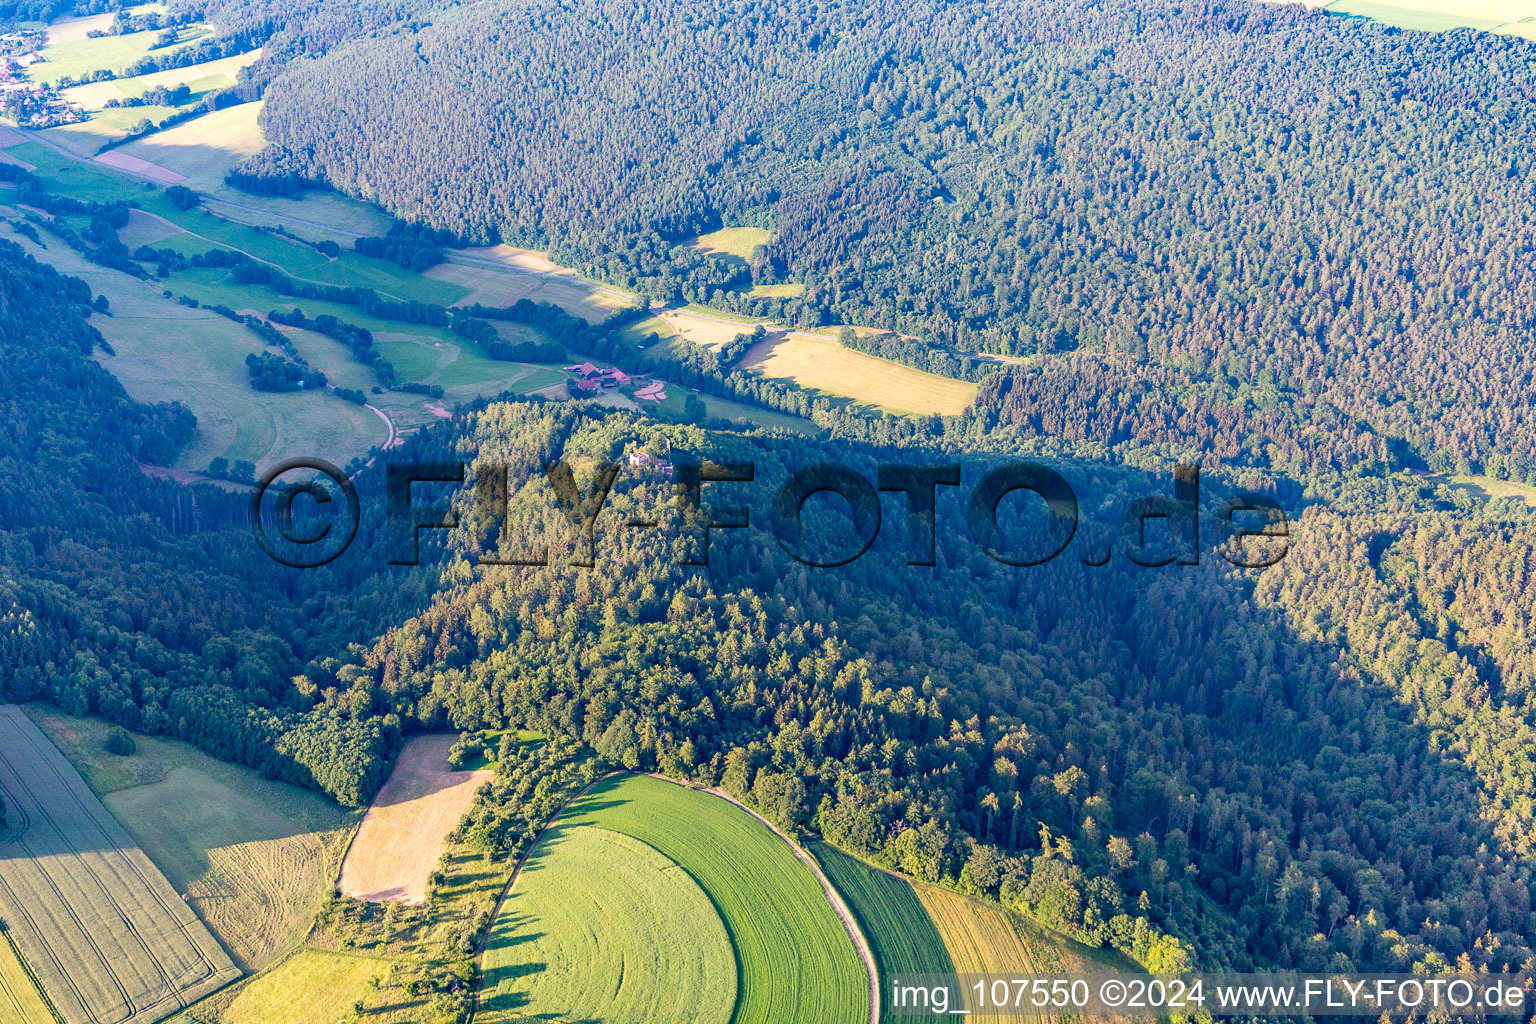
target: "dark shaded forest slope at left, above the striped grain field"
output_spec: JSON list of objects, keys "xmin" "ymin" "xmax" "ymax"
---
[{"xmin": 0, "ymin": 241, "xmax": 395, "ymax": 803}]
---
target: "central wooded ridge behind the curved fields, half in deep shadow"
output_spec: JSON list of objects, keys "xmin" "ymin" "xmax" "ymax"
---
[{"xmin": 276, "ymin": 402, "xmax": 1536, "ymax": 970}]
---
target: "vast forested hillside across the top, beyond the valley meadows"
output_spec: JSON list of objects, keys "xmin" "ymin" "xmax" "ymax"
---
[{"xmin": 219, "ymin": 0, "xmax": 1536, "ymax": 476}]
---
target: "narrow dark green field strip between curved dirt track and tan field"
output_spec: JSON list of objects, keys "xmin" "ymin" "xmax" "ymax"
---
[{"xmin": 811, "ymin": 843, "xmax": 955, "ymax": 1024}]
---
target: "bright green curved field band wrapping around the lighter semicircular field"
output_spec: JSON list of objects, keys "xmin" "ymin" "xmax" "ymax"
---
[{"xmin": 561, "ymin": 775, "xmax": 869, "ymax": 1024}]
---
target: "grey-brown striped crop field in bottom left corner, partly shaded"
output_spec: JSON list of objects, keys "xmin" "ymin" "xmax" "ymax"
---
[{"xmin": 0, "ymin": 706, "xmax": 240, "ymax": 1024}]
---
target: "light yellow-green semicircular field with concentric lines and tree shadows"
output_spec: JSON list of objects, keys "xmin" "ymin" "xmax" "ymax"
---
[{"xmin": 476, "ymin": 824, "xmax": 736, "ymax": 1024}]
